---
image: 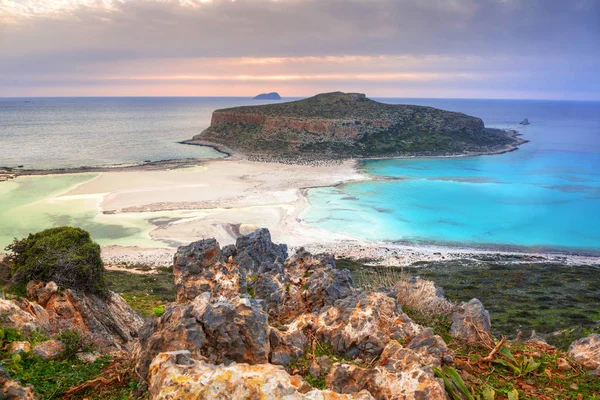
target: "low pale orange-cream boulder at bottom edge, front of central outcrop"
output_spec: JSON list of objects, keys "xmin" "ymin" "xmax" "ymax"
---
[{"xmin": 149, "ymin": 351, "xmax": 373, "ymax": 400}]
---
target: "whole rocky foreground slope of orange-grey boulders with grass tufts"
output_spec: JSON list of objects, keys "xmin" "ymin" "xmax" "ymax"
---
[{"xmin": 0, "ymin": 229, "xmax": 600, "ymax": 399}]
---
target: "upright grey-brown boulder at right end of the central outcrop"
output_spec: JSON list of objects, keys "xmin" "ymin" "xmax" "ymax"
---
[{"xmin": 450, "ymin": 299, "xmax": 493, "ymax": 344}]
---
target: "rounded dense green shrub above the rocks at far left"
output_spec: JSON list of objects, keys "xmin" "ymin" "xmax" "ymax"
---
[{"xmin": 6, "ymin": 226, "xmax": 107, "ymax": 294}]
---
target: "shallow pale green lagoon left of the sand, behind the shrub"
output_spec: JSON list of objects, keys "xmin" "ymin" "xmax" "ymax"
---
[{"xmin": 0, "ymin": 174, "xmax": 205, "ymax": 248}]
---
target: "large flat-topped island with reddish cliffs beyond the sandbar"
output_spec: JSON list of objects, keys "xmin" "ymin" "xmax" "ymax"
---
[{"xmin": 186, "ymin": 92, "xmax": 525, "ymax": 159}]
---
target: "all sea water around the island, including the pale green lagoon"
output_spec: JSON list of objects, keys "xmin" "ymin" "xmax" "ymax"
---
[{"xmin": 0, "ymin": 97, "xmax": 600, "ymax": 254}]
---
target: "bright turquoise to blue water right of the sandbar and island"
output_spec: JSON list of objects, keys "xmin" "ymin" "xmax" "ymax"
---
[{"xmin": 304, "ymin": 100, "xmax": 600, "ymax": 252}]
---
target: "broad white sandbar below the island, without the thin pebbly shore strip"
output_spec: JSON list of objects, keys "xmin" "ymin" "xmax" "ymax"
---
[{"xmin": 62, "ymin": 160, "xmax": 370, "ymax": 265}]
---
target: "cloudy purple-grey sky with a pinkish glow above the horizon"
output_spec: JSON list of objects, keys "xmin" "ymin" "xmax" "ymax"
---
[{"xmin": 0, "ymin": 0, "xmax": 600, "ymax": 100}]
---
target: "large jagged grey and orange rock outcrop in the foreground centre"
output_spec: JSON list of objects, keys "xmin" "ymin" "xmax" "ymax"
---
[{"xmin": 134, "ymin": 230, "xmax": 453, "ymax": 399}]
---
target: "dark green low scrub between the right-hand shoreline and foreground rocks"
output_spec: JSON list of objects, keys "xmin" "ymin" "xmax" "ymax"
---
[{"xmin": 336, "ymin": 257, "xmax": 600, "ymax": 350}]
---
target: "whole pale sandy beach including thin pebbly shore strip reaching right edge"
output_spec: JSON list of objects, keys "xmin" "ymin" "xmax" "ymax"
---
[{"xmin": 2, "ymin": 157, "xmax": 600, "ymax": 267}]
